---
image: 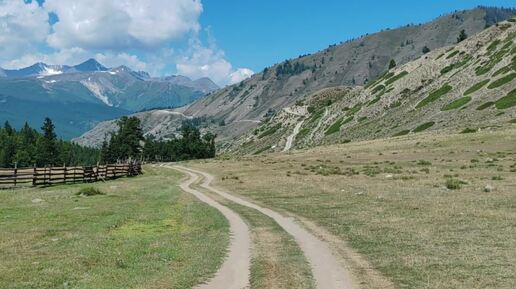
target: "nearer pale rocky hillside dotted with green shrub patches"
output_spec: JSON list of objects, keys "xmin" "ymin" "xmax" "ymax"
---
[{"xmin": 230, "ymin": 18, "xmax": 516, "ymax": 154}]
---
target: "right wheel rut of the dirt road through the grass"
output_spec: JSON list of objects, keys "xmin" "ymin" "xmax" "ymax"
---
[{"xmin": 173, "ymin": 166, "xmax": 353, "ymax": 289}]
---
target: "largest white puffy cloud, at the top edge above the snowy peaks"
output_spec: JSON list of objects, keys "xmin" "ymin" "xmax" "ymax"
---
[{"xmin": 44, "ymin": 0, "xmax": 203, "ymax": 50}]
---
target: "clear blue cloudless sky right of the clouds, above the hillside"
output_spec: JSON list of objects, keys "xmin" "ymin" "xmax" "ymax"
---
[{"xmin": 201, "ymin": 0, "xmax": 516, "ymax": 71}]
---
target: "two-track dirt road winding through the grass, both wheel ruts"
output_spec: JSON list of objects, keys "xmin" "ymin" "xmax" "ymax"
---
[{"xmin": 167, "ymin": 166, "xmax": 353, "ymax": 289}]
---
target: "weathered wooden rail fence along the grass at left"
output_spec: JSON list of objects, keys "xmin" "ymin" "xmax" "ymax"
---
[{"xmin": 0, "ymin": 162, "xmax": 142, "ymax": 187}]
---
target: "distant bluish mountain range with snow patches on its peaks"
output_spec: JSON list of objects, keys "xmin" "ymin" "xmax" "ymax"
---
[{"xmin": 0, "ymin": 59, "xmax": 218, "ymax": 138}]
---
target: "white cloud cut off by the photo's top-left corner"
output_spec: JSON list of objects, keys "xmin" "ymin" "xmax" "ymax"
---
[{"xmin": 0, "ymin": 0, "xmax": 50, "ymax": 59}]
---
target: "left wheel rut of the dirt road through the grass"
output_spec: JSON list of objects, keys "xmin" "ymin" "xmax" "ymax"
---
[{"xmin": 166, "ymin": 166, "xmax": 251, "ymax": 289}]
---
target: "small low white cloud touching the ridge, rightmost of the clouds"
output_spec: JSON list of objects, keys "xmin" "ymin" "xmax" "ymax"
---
[{"xmin": 176, "ymin": 40, "xmax": 254, "ymax": 86}]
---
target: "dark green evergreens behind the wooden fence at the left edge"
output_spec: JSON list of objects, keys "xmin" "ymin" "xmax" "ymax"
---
[{"xmin": 0, "ymin": 118, "xmax": 99, "ymax": 168}]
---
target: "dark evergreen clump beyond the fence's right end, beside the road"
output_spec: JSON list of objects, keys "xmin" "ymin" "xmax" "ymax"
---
[{"xmin": 100, "ymin": 117, "xmax": 215, "ymax": 163}]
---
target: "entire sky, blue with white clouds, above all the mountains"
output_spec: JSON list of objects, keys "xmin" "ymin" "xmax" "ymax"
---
[{"xmin": 0, "ymin": 0, "xmax": 515, "ymax": 85}]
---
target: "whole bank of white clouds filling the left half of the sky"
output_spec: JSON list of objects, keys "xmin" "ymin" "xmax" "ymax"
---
[{"xmin": 0, "ymin": 0, "xmax": 253, "ymax": 86}]
